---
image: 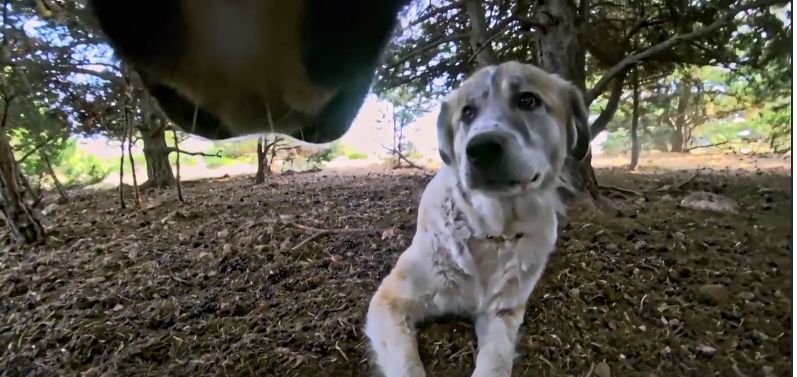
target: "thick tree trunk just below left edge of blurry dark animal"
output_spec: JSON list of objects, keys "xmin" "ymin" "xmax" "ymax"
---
[{"xmin": 140, "ymin": 122, "xmax": 174, "ymax": 187}]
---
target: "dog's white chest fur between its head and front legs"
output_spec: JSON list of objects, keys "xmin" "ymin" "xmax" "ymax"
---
[{"xmin": 414, "ymin": 169, "xmax": 556, "ymax": 315}]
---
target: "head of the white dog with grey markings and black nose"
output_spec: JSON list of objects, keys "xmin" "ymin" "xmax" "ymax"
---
[{"xmin": 437, "ymin": 62, "xmax": 590, "ymax": 196}]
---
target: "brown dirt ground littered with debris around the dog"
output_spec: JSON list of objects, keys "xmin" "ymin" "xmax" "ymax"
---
[{"xmin": 0, "ymin": 155, "xmax": 792, "ymax": 377}]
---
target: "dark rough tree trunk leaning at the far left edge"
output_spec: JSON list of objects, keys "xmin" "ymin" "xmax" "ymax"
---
[{"xmin": 0, "ymin": 129, "xmax": 46, "ymax": 243}]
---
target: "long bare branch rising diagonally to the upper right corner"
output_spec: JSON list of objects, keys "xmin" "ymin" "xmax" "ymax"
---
[{"xmin": 586, "ymin": 0, "xmax": 780, "ymax": 104}]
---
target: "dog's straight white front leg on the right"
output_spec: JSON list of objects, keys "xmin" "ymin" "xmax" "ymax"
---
[{"xmin": 472, "ymin": 306, "xmax": 525, "ymax": 377}]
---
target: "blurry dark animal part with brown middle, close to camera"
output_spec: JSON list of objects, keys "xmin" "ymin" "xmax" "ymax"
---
[{"xmin": 89, "ymin": 0, "xmax": 409, "ymax": 143}]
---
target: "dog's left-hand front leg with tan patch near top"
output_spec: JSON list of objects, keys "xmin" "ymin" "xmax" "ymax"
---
[{"xmin": 365, "ymin": 259, "xmax": 427, "ymax": 377}]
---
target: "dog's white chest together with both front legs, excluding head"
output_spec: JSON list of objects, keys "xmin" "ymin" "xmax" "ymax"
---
[{"xmin": 365, "ymin": 167, "xmax": 560, "ymax": 377}]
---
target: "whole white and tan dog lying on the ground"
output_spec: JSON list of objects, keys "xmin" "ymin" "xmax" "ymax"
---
[{"xmin": 366, "ymin": 62, "xmax": 590, "ymax": 377}]
